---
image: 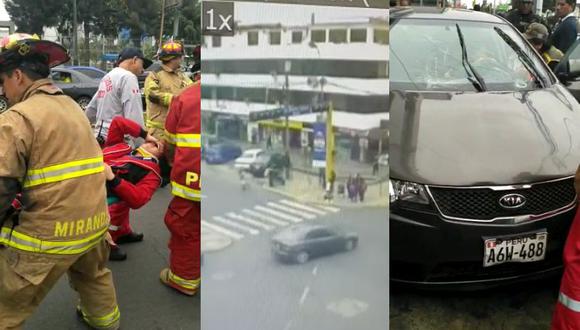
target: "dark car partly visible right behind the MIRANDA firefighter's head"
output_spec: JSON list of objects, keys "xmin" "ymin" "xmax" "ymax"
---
[{"xmin": 51, "ymin": 67, "xmax": 99, "ymax": 110}]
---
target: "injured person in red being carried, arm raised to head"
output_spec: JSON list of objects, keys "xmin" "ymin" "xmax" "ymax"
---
[{"xmin": 103, "ymin": 116, "xmax": 163, "ymax": 261}]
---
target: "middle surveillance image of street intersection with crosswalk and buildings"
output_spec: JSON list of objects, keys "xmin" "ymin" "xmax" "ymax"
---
[{"xmin": 201, "ymin": 3, "xmax": 388, "ymax": 330}]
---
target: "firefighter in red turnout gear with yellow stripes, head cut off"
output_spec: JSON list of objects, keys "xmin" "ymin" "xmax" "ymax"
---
[{"xmin": 160, "ymin": 82, "xmax": 201, "ymax": 296}]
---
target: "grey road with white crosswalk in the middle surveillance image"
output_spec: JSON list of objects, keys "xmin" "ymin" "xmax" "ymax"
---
[{"xmin": 202, "ymin": 166, "xmax": 388, "ymax": 330}]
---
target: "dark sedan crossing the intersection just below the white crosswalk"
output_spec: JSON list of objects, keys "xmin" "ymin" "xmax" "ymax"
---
[{"xmin": 272, "ymin": 223, "xmax": 358, "ymax": 264}]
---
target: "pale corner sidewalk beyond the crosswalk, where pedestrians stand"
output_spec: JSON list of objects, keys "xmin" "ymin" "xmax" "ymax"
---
[{"xmin": 258, "ymin": 170, "xmax": 388, "ymax": 208}]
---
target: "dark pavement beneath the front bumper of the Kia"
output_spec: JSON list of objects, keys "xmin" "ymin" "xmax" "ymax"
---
[{"xmin": 389, "ymin": 278, "xmax": 560, "ymax": 330}]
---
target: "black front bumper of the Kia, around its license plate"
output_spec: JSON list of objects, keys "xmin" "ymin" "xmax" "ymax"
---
[{"xmin": 389, "ymin": 207, "xmax": 576, "ymax": 289}]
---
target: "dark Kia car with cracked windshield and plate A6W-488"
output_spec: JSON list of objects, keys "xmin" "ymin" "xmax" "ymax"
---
[{"xmin": 389, "ymin": 8, "xmax": 580, "ymax": 288}]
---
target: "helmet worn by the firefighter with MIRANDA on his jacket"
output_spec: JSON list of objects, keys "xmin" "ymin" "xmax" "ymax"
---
[{"xmin": 0, "ymin": 33, "xmax": 70, "ymax": 70}]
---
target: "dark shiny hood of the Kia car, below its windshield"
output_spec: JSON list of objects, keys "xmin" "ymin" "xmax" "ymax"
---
[{"xmin": 389, "ymin": 84, "xmax": 580, "ymax": 186}]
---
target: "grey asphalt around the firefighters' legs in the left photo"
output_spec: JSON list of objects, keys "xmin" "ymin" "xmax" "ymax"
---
[{"xmin": 25, "ymin": 187, "xmax": 200, "ymax": 330}]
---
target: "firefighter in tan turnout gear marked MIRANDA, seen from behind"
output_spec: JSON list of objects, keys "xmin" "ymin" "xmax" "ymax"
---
[{"xmin": 0, "ymin": 34, "xmax": 120, "ymax": 329}]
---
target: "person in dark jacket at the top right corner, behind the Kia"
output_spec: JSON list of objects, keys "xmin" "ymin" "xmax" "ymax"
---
[{"xmin": 550, "ymin": 0, "xmax": 578, "ymax": 53}]
